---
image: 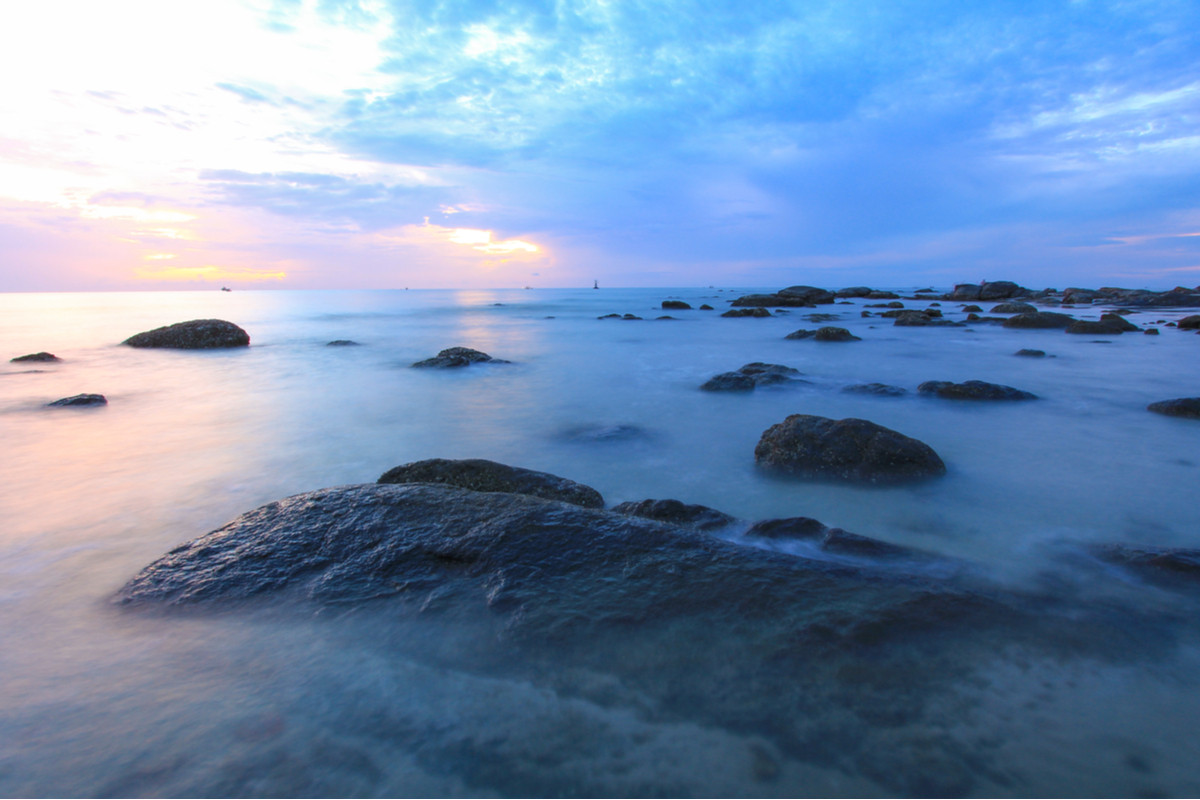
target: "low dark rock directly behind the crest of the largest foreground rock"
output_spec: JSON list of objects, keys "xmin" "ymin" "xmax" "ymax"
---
[{"xmin": 378, "ymin": 458, "xmax": 604, "ymax": 509}]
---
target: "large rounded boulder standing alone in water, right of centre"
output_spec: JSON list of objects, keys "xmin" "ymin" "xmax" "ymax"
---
[{"xmin": 755, "ymin": 414, "xmax": 946, "ymax": 482}]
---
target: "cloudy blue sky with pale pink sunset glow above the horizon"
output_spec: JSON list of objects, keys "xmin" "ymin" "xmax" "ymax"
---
[{"xmin": 0, "ymin": 0, "xmax": 1200, "ymax": 291}]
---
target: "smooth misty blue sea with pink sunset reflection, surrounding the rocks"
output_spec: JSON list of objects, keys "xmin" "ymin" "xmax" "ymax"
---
[{"xmin": 0, "ymin": 287, "xmax": 1200, "ymax": 796}]
